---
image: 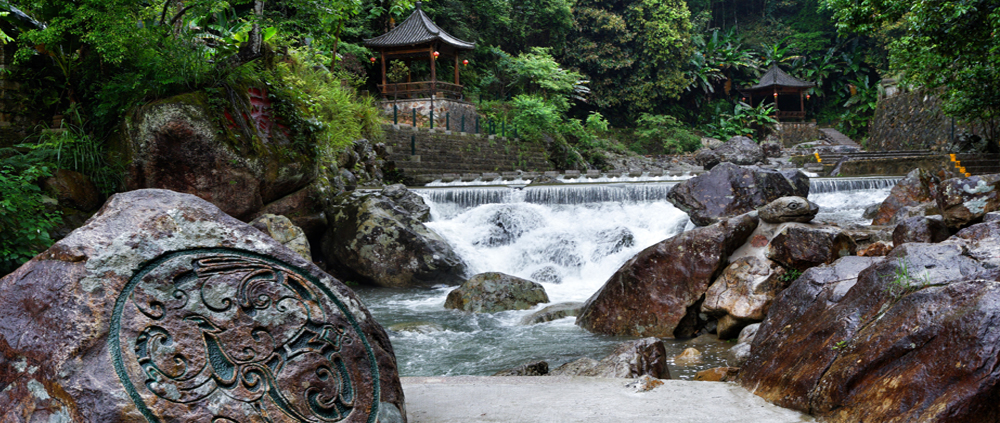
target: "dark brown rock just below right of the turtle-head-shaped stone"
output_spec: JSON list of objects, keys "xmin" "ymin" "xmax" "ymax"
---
[{"xmin": 767, "ymin": 225, "xmax": 857, "ymax": 270}]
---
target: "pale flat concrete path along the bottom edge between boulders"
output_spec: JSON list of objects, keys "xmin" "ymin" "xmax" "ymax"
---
[{"xmin": 401, "ymin": 376, "xmax": 815, "ymax": 423}]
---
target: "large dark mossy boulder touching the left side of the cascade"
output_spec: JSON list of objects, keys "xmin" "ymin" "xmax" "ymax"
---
[{"xmin": 322, "ymin": 192, "xmax": 465, "ymax": 288}]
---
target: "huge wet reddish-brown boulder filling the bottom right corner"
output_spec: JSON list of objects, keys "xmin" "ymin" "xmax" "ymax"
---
[{"xmin": 739, "ymin": 229, "xmax": 1000, "ymax": 422}]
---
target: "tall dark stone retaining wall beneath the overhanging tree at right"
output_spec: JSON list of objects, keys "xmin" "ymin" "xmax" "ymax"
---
[{"xmin": 868, "ymin": 90, "xmax": 984, "ymax": 153}]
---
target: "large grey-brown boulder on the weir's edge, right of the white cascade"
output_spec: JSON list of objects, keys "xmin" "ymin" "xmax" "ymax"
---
[{"xmin": 667, "ymin": 163, "xmax": 809, "ymax": 226}]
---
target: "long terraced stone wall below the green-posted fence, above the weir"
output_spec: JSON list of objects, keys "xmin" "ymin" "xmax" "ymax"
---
[{"xmin": 384, "ymin": 125, "xmax": 554, "ymax": 180}]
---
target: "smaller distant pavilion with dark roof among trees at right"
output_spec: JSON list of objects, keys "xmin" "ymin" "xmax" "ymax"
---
[{"xmin": 739, "ymin": 65, "xmax": 816, "ymax": 120}]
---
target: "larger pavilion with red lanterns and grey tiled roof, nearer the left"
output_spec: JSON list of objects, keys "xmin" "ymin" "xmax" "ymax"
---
[{"xmin": 365, "ymin": 2, "xmax": 476, "ymax": 99}]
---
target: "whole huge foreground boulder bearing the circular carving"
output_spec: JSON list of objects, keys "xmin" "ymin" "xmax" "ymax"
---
[{"xmin": 0, "ymin": 190, "xmax": 405, "ymax": 423}]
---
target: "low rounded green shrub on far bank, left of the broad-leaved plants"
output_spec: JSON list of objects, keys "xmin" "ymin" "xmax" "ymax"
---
[{"xmin": 630, "ymin": 113, "xmax": 701, "ymax": 154}]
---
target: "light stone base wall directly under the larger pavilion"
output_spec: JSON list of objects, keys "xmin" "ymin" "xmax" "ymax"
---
[{"xmin": 382, "ymin": 98, "xmax": 479, "ymax": 132}]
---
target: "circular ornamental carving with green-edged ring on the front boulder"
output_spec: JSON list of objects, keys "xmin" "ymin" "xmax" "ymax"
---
[{"xmin": 108, "ymin": 249, "xmax": 379, "ymax": 423}]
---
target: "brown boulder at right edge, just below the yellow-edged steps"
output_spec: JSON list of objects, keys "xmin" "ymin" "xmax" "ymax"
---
[{"xmin": 937, "ymin": 174, "xmax": 1000, "ymax": 229}]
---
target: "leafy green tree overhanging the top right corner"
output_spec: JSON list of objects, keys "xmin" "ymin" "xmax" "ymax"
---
[{"xmin": 823, "ymin": 0, "xmax": 1000, "ymax": 145}]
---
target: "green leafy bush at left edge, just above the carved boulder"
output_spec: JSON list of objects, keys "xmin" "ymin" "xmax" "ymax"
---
[{"xmin": 0, "ymin": 157, "xmax": 61, "ymax": 275}]
